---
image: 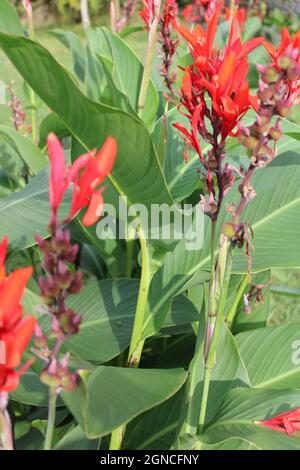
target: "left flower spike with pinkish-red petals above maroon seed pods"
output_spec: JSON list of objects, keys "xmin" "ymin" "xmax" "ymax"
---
[{"xmin": 34, "ymin": 134, "xmax": 117, "ymax": 393}]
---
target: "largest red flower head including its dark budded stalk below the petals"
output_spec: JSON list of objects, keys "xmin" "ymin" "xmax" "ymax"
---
[{"xmin": 174, "ymin": 5, "xmax": 263, "ymax": 221}]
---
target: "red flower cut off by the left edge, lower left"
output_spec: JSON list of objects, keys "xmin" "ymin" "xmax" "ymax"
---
[{"xmin": 0, "ymin": 237, "xmax": 36, "ymax": 392}]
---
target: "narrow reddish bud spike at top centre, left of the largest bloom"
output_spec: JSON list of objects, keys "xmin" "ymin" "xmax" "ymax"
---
[{"xmin": 159, "ymin": 0, "xmax": 179, "ymax": 95}]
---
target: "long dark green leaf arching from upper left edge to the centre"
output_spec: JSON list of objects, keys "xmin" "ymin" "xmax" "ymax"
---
[{"xmin": 0, "ymin": 33, "xmax": 172, "ymax": 215}]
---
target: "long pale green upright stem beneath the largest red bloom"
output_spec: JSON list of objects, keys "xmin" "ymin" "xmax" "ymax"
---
[{"xmin": 198, "ymin": 235, "xmax": 232, "ymax": 434}]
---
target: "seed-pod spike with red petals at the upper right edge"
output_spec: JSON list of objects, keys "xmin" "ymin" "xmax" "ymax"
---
[{"xmin": 234, "ymin": 28, "xmax": 300, "ymax": 223}]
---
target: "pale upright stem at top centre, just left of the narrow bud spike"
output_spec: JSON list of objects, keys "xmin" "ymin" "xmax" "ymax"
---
[{"xmin": 138, "ymin": 18, "xmax": 158, "ymax": 117}]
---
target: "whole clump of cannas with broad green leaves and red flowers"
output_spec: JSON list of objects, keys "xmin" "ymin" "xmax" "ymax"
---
[{"xmin": 0, "ymin": 0, "xmax": 300, "ymax": 450}]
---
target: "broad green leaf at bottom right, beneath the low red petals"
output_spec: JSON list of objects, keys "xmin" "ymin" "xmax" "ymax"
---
[{"xmin": 204, "ymin": 388, "xmax": 300, "ymax": 450}]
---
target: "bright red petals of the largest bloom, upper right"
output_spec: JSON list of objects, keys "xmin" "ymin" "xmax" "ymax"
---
[{"xmin": 177, "ymin": 8, "xmax": 263, "ymax": 143}]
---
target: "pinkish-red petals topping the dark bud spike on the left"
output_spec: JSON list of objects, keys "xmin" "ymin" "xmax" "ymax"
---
[{"xmin": 48, "ymin": 134, "xmax": 117, "ymax": 226}]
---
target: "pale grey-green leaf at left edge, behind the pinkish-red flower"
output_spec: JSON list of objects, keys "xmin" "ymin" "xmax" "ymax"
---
[{"xmin": 0, "ymin": 171, "xmax": 70, "ymax": 249}]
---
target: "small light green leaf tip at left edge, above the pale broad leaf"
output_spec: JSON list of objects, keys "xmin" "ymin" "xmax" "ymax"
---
[{"xmin": 0, "ymin": 126, "xmax": 48, "ymax": 175}]
